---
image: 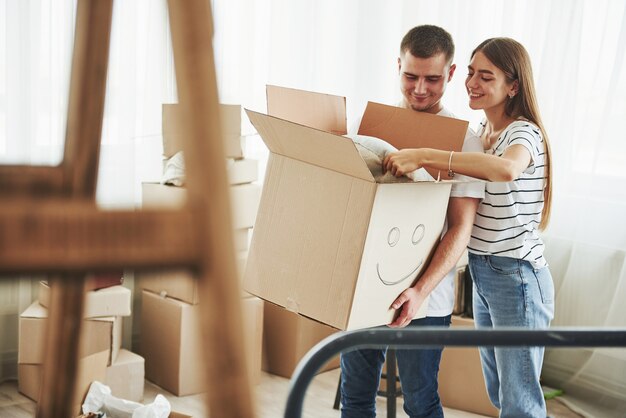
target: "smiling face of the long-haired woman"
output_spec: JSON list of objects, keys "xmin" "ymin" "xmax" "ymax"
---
[{"xmin": 465, "ymin": 51, "xmax": 517, "ymax": 110}]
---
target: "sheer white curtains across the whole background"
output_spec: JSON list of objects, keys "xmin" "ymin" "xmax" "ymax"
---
[{"xmin": 0, "ymin": 0, "xmax": 626, "ymax": 414}]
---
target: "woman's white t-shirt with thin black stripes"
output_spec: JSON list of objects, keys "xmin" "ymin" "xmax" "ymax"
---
[{"xmin": 468, "ymin": 120, "xmax": 547, "ymax": 268}]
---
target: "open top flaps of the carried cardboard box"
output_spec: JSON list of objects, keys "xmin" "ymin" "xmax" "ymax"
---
[{"xmin": 246, "ymin": 94, "xmax": 469, "ymax": 181}]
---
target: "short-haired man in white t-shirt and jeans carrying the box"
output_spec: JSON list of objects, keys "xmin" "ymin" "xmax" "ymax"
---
[{"xmin": 341, "ymin": 25, "xmax": 484, "ymax": 418}]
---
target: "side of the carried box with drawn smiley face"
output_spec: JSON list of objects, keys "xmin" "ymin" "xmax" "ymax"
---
[{"xmin": 349, "ymin": 182, "xmax": 450, "ymax": 329}]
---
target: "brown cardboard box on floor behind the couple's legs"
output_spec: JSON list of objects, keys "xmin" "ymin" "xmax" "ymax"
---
[{"xmin": 439, "ymin": 316, "xmax": 498, "ymax": 417}]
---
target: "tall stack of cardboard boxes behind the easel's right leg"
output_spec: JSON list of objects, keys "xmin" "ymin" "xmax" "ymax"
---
[{"xmin": 137, "ymin": 104, "xmax": 263, "ymax": 396}]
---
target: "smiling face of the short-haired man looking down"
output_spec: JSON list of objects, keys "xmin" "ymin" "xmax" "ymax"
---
[{"xmin": 398, "ymin": 51, "xmax": 456, "ymax": 113}]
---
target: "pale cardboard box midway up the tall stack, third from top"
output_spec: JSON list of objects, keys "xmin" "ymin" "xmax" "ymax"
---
[{"xmin": 141, "ymin": 183, "xmax": 261, "ymax": 230}]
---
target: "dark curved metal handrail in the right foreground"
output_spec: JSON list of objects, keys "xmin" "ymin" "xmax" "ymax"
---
[{"xmin": 284, "ymin": 327, "xmax": 626, "ymax": 418}]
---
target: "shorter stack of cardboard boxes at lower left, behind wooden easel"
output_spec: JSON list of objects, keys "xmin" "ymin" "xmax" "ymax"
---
[{"xmin": 18, "ymin": 273, "xmax": 139, "ymax": 410}]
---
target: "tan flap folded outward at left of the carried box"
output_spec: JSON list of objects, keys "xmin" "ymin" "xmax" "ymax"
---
[{"xmin": 246, "ymin": 109, "xmax": 374, "ymax": 183}]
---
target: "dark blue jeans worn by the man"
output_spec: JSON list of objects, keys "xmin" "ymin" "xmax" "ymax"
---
[{"xmin": 341, "ymin": 315, "xmax": 451, "ymax": 418}]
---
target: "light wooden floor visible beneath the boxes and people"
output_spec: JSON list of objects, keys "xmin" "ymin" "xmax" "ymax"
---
[{"xmin": 0, "ymin": 370, "xmax": 580, "ymax": 418}]
